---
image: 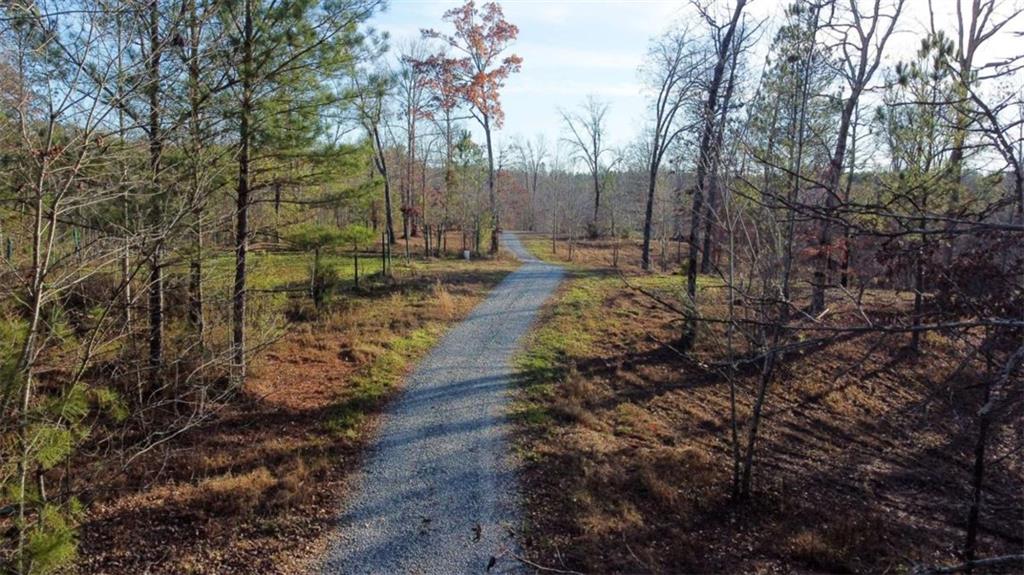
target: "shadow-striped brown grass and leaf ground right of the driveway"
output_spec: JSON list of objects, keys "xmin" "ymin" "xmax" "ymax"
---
[{"xmin": 518, "ymin": 241, "xmax": 1024, "ymax": 573}]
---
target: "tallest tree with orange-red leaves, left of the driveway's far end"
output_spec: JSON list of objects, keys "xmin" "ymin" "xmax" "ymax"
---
[{"xmin": 418, "ymin": 0, "xmax": 522, "ymax": 253}]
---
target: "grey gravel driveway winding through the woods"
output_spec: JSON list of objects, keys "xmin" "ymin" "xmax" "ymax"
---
[{"xmin": 324, "ymin": 233, "xmax": 562, "ymax": 574}]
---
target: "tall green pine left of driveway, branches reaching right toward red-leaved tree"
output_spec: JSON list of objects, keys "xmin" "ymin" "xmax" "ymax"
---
[{"xmin": 220, "ymin": 0, "xmax": 381, "ymax": 384}]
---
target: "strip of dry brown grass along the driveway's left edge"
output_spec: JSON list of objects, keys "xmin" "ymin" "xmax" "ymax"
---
[{"xmin": 72, "ymin": 249, "xmax": 516, "ymax": 574}]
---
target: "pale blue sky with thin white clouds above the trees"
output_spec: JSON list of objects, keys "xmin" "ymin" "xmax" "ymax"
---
[{"xmin": 371, "ymin": 0, "xmax": 1024, "ymax": 154}]
